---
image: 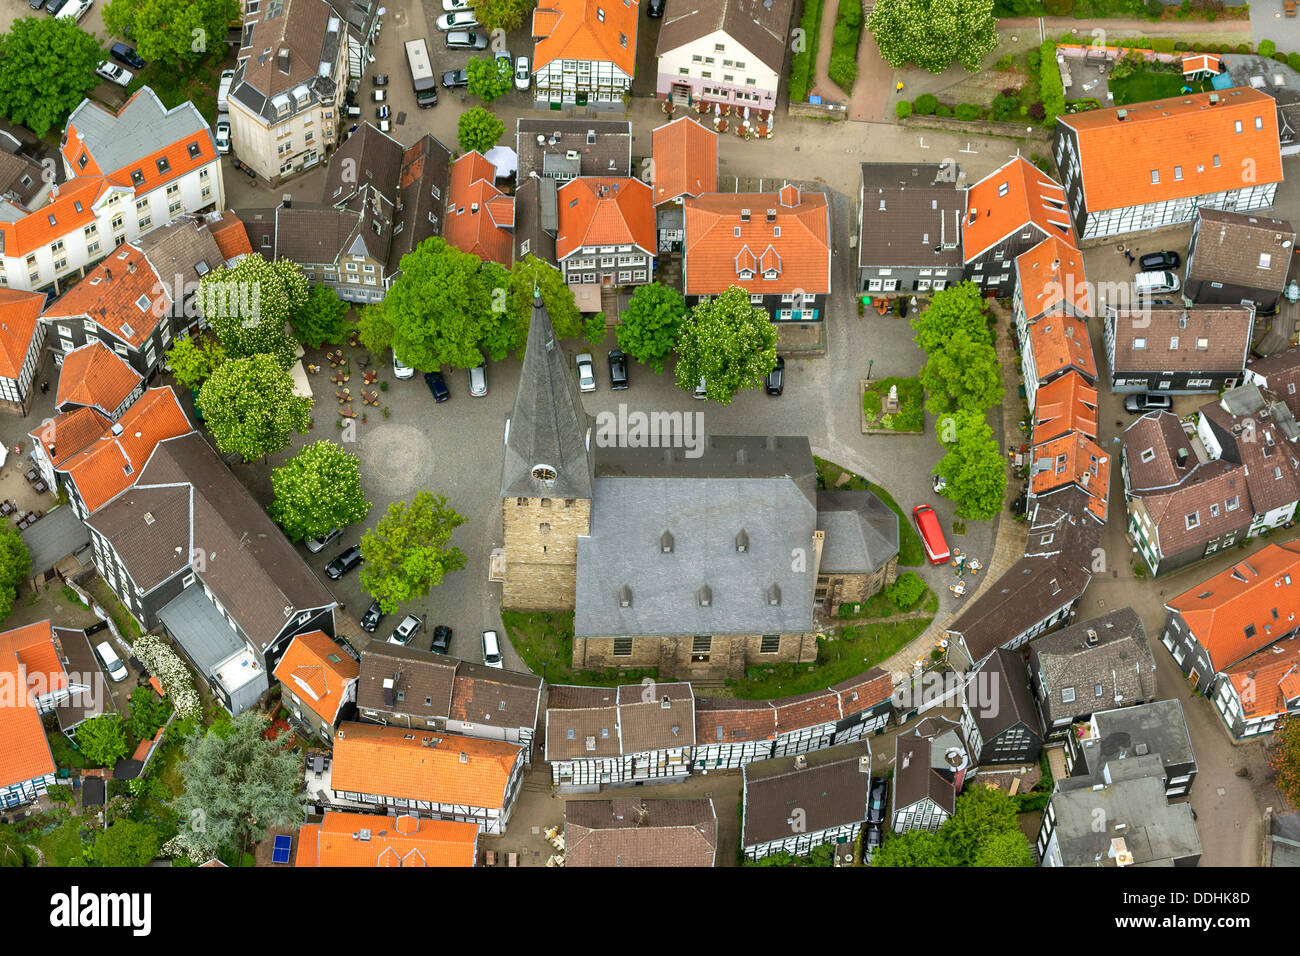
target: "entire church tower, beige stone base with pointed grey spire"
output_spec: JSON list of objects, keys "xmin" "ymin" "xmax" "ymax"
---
[{"xmin": 501, "ymin": 291, "xmax": 595, "ymax": 611}]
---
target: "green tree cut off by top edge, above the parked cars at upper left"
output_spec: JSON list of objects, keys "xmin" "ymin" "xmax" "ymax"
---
[{"xmin": 104, "ymin": 0, "xmax": 243, "ymax": 69}]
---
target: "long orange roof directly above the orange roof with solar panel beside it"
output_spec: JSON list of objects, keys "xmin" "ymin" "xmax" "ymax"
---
[{"xmin": 330, "ymin": 723, "xmax": 521, "ymax": 809}]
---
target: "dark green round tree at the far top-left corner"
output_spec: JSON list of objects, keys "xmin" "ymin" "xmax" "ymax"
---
[{"xmin": 0, "ymin": 17, "xmax": 104, "ymax": 137}]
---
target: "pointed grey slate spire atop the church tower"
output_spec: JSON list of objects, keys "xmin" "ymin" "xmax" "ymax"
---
[{"xmin": 501, "ymin": 289, "xmax": 595, "ymax": 498}]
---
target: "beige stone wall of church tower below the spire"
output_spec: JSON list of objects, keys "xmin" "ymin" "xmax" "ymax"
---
[{"xmin": 501, "ymin": 498, "xmax": 592, "ymax": 611}]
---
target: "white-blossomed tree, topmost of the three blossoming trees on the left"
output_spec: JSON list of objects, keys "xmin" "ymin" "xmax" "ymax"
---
[{"xmin": 199, "ymin": 254, "xmax": 308, "ymax": 368}]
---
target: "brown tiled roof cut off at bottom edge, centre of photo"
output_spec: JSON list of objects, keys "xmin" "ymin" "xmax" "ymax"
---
[{"xmin": 564, "ymin": 797, "xmax": 718, "ymax": 866}]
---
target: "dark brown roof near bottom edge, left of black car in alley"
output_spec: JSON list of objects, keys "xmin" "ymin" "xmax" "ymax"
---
[{"xmin": 741, "ymin": 740, "xmax": 871, "ymax": 847}]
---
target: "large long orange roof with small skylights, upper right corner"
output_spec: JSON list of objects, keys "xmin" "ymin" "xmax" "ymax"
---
[{"xmin": 1058, "ymin": 86, "xmax": 1282, "ymax": 213}]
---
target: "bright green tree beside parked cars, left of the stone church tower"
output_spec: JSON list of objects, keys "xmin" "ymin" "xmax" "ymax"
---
[{"xmin": 361, "ymin": 492, "xmax": 465, "ymax": 614}]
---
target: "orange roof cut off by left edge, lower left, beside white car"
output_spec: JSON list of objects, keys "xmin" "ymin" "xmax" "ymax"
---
[{"xmin": 0, "ymin": 620, "xmax": 60, "ymax": 787}]
